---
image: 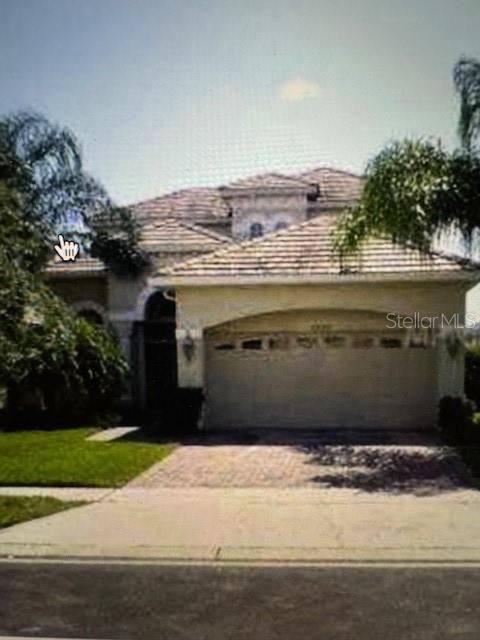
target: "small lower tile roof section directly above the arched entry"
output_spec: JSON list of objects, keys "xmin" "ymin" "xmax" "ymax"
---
[{"xmin": 140, "ymin": 218, "xmax": 231, "ymax": 250}]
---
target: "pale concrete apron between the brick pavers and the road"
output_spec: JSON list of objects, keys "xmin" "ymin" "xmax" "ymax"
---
[{"xmin": 0, "ymin": 488, "xmax": 480, "ymax": 563}]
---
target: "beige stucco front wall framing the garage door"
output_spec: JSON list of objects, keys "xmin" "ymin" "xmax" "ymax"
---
[{"xmin": 177, "ymin": 282, "xmax": 465, "ymax": 410}]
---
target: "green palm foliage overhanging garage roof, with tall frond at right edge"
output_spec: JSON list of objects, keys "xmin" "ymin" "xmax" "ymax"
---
[{"xmin": 335, "ymin": 58, "xmax": 480, "ymax": 254}]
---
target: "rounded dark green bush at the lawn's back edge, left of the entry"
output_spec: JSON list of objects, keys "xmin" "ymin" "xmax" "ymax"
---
[{"xmin": 0, "ymin": 282, "xmax": 127, "ymax": 426}]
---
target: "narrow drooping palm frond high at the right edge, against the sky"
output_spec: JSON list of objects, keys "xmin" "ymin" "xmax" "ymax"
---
[{"xmin": 453, "ymin": 58, "xmax": 480, "ymax": 151}]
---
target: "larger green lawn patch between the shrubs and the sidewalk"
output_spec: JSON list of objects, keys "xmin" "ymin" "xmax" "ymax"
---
[{"xmin": 0, "ymin": 429, "xmax": 174, "ymax": 487}]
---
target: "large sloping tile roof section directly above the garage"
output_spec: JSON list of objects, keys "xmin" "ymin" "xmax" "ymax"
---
[{"xmin": 158, "ymin": 214, "xmax": 470, "ymax": 278}]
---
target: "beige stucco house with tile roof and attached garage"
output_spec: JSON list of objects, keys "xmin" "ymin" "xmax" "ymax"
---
[{"xmin": 48, "ymin": 168, "xmax": 479, "ymax": 429}]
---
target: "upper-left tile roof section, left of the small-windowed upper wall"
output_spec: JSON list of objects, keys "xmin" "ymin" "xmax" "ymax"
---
[{"xmin": 132, "ymin": 187, "xmax": 230, "ymax": 224}]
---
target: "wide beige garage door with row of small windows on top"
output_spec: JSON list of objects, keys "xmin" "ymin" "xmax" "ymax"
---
[{"xmin": 205, "ymin": 334, "xmax": 436, "ymax": 429}]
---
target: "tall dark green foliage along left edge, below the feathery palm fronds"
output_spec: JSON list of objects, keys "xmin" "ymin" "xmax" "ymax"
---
[{"xmin": 0, "ymin": 181, "xmax": 127, "ymax": 427}]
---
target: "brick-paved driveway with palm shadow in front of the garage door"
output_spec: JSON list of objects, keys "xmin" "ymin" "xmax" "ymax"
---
[{"xmin": 129, "ymin": 430, "xmax": 471, "ymax": 495}]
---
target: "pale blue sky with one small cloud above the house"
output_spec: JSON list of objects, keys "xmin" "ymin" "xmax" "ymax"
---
[{"xmin": 0, "ymin": 0, "xmax": 480, "ymax": 203}]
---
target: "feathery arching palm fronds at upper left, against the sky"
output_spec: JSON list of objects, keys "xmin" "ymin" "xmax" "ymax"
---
[{"xmin": 0, "ymin": 112, "xmax": 148, "ymax": 276}]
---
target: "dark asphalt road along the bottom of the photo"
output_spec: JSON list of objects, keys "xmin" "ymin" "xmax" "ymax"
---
[{"xmin": 0, "ymin": 562, "xmax": 480, "ymax": 640}]
